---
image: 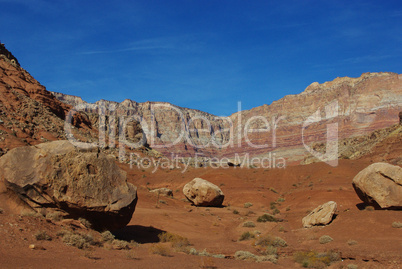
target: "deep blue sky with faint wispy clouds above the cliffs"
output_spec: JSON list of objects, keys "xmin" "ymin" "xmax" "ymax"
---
[{"xmin": 0, "ymin": 0, "xmax": 402, "ymax": 116}]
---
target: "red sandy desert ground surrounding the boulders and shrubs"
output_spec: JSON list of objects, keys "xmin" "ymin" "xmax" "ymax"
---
[{"xmin": 0, "ymin": 157, "xmax": 402, "ymax": 268}]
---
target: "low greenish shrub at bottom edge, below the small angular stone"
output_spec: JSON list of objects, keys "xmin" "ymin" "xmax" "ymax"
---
[{"xmin": 293, "ymin": 251, "xmax": 340, "ymax": 268}]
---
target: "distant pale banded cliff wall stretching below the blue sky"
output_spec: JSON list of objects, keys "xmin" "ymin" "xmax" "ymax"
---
[{"xmin": 56, "ymin": 73, "xmax": 402, "ymax": 163}]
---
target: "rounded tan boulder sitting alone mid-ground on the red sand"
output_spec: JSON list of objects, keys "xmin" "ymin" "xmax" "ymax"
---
[{"xmin": 183, "ymin": 178, "xmax": 225, "ymax": 206}]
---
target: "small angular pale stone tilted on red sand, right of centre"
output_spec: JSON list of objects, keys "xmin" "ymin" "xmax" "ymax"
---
[{"xmin": 302, "ymin": 201, "xmax": 337, "ymax": 228}]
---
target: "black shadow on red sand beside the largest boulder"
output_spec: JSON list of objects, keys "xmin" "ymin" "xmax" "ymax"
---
[{"xmin": 113, "ymin": 225, "xmax": 165, "ymax": 244}]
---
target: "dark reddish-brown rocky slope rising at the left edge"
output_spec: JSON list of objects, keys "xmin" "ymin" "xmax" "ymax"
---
[{"xmin": 0, "ymin": 45, "xmax": 91, "ymax": 155}]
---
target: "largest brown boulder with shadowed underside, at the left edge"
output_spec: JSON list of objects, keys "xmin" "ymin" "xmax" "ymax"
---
[{"xmin": 0, "ymin": 141, "xmax": 137, "ymax": 230}]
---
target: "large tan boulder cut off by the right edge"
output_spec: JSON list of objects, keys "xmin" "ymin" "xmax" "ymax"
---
[{"xmin": 352, "ymin": 163, "xmax": 402, "ymax": 208}]
